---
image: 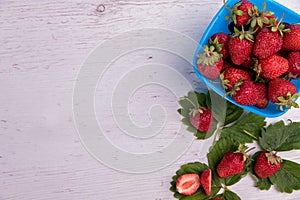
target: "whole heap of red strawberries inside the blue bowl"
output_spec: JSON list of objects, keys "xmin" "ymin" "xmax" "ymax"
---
[{"xmin": 197, "ymin": 0, "xmax": 300, "ymax": 110}]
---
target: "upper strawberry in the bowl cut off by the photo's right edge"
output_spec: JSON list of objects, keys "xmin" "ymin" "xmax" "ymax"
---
[{"xmin": 283, "ymin": 24, "xmax": 300, "ymax": 51}]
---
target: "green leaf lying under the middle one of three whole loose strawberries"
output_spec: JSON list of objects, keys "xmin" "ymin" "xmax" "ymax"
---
[{"xmin": 207, "ymin": 138, "xmax": 248, "ymax": 186}]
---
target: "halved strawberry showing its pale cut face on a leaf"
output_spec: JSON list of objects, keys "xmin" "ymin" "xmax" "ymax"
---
[{"xmin": 176, "ymin": 174, "xmax": 200, "ymax": 196}]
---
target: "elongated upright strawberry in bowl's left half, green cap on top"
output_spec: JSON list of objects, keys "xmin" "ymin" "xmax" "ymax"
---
[{"xmin": 228, "ymin": 28, "xmax": 253, "ymax": 65}]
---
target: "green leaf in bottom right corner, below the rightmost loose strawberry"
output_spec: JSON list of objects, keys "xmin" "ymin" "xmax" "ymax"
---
[{"xmin": 269, "ymin": 160, "xmax": 300, "ymax": 193}]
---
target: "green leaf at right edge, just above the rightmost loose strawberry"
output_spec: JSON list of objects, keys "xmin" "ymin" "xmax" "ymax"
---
[{"xmin": 259, "ymin": 121, "xmax": 300, "ymax": 151}]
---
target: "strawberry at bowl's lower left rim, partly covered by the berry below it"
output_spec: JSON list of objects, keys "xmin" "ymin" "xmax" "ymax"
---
[{"xmin": 220, "ymin": 67, "xmax": 251, "ymax": 90}]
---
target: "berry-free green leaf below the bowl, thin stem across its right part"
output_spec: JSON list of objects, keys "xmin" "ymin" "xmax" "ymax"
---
[{"xmin": 220, "ymin": 113, "xmax": 266, "ymax": 144}]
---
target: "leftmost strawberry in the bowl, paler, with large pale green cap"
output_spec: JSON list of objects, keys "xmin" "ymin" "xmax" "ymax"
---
[{"xmin": 197, "ymin": 46, "xmax": 223, "ymax": 80}]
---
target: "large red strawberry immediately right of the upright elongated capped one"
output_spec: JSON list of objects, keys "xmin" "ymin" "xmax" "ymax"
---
[{"xmin": 253, "ymin": 28, "xmax": 283, "ymax": 59}]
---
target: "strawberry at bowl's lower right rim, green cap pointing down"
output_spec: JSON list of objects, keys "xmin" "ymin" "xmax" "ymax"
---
[{"xmin": 268, "ymin": 78, "xmax": 300, "ymax": 110}]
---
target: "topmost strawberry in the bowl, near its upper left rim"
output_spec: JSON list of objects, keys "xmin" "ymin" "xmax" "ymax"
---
[{"xmin": 224, "ymin": 0, "xmax": 253, "ymax": 27}]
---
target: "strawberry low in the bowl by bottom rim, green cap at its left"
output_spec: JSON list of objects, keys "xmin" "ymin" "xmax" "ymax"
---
[{"xmin": 230, "ymin": 81, "xmax": 259, "ymax": 106}]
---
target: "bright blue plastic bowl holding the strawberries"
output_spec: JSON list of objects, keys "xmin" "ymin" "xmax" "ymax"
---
[{"xmin": 193, "ymin": 0, "xmax": 300, "ymax": 118}]
